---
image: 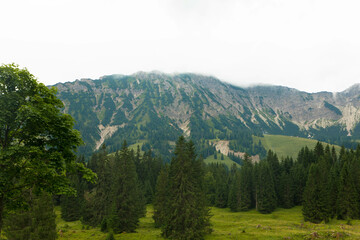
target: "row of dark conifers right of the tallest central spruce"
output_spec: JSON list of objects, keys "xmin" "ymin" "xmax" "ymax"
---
[{"xmin": 205, "ymin": 142, "xmax": 360, "ymax": 223}]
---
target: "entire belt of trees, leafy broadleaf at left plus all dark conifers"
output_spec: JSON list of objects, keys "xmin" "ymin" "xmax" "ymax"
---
[{"xmin": 0, "ymin": 65, "xmax": 360, "ymax": 240}]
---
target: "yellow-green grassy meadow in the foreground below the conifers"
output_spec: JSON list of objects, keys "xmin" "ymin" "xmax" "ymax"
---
[{"xmin": 56, "ymin": 206, "xmax": 360, "ymax": 240}]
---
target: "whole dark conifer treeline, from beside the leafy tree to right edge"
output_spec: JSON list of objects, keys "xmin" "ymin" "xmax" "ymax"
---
[{"xmin": 55, "ymin": 137, "xmax": 360, "ymax": 239}]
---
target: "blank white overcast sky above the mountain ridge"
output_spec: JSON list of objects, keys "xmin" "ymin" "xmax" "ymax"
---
[{"xmin": 0, "ymin": 0, "xmax": 360, "ymax": 92}]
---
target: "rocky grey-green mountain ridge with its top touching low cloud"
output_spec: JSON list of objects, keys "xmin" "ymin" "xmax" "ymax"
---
[{"xmin": 55, "ymin": 72, "xmax": 360, "ymax": 156}]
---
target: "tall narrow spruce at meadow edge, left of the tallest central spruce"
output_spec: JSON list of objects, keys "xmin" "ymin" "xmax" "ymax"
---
[{"xmin": 108, "ymin": 141, "xmax": 145, "ymax": 233}]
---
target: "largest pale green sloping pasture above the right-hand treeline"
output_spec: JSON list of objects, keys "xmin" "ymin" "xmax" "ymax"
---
[{"xmin": 254, "ymin": 135, "xmax": 340, "ymax": 159}]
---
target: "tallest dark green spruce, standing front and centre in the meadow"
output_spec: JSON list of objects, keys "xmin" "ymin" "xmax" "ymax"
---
[{"xmin": 162, "ymin": 136, "xmax": 210, "ymax": 239}]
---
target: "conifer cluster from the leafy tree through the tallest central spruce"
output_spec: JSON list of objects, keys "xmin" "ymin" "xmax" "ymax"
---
[{"xmin": 60, "ymin": 137, "xmax": 211, "ymax": 239}]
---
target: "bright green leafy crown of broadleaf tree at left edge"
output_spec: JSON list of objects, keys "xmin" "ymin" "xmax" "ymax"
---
[{"xmin": 0, "ymin": 64, "xmax": 94, "ymax": 232}]
